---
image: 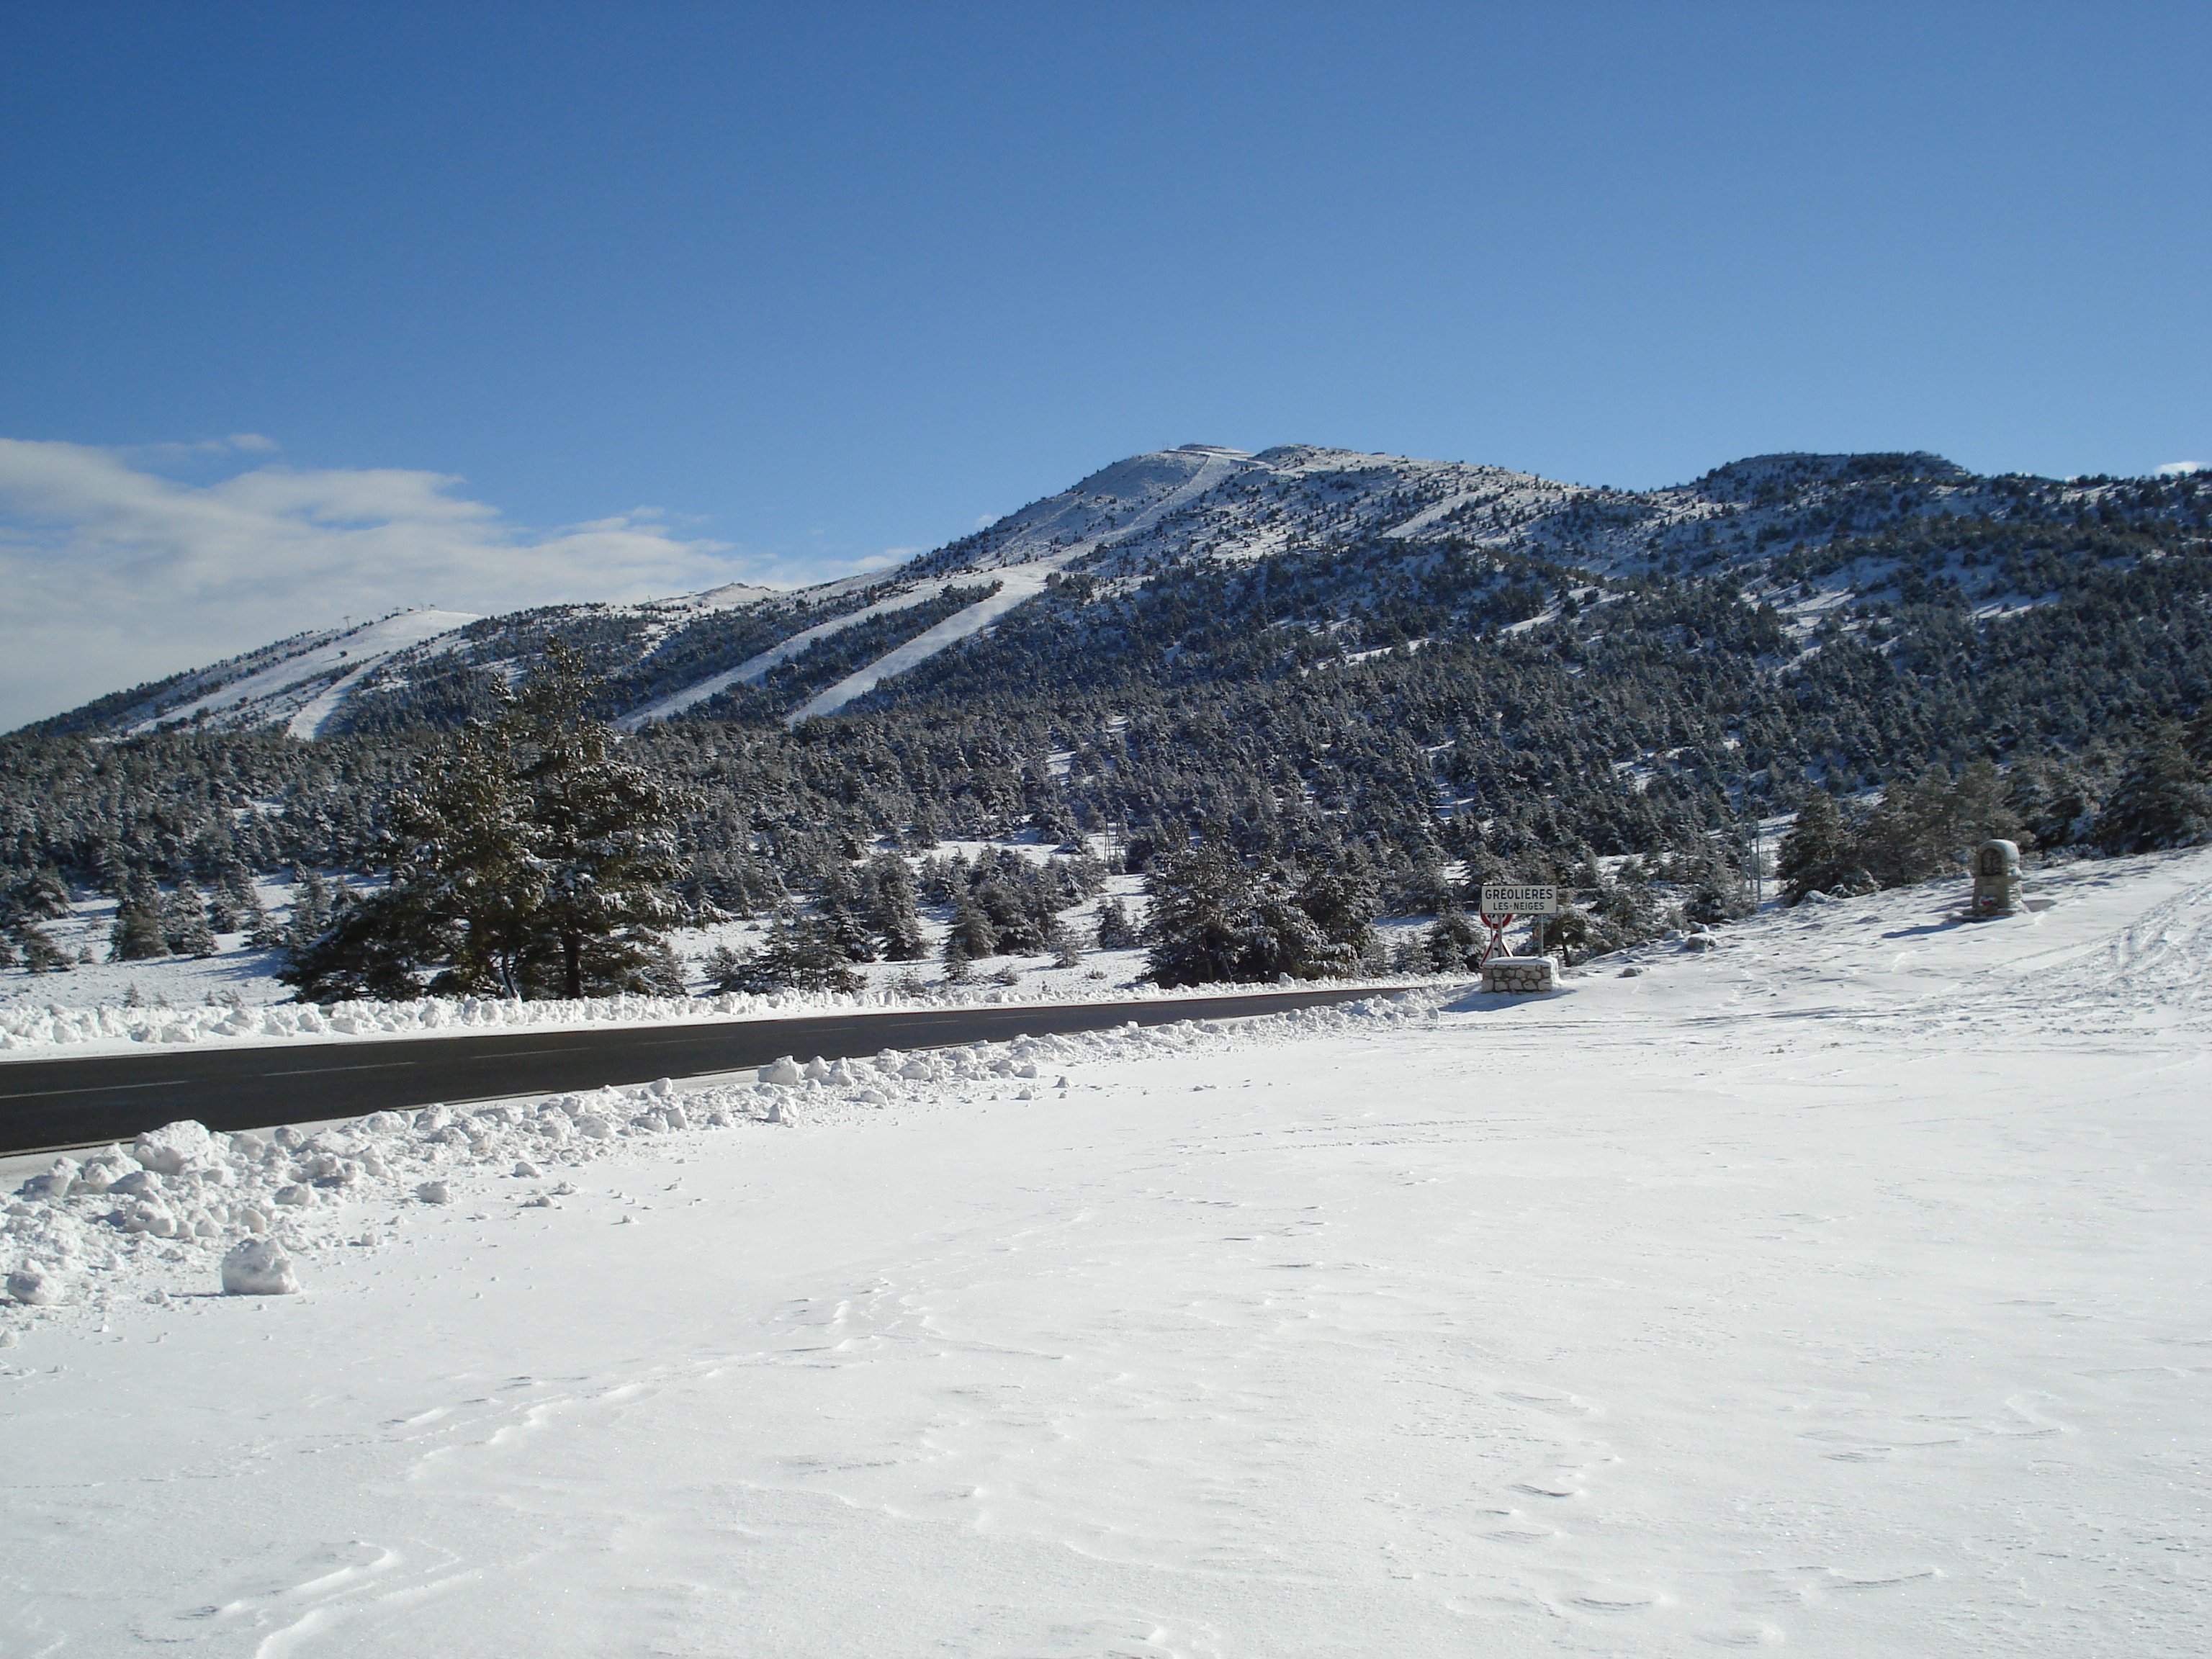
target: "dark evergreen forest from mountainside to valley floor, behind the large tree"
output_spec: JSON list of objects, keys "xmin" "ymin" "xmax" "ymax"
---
[{"xmin": 0, "ymin": 451, "xmax": 2212, "ymax": 989}]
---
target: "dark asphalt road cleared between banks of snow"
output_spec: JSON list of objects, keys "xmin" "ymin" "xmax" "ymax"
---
[{"xmin": 0, "ymin": 989, "xmax": 1376, "ymax": 1155}]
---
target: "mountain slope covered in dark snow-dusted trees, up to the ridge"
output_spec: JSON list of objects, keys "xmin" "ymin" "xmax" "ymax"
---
[{"xmin": 0, "ymin": 449, "xmax": 2212, "ymax": 942}]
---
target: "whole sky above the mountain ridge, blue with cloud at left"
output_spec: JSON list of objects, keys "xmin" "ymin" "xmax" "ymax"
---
[{"xmin": 0, "ymin": 0, "xmax": 2212, "ymax": 726}]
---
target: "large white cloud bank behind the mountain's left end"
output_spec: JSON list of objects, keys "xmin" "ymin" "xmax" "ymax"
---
[{"xmin": 0, "ymin": 433, "xmax": 761, "ymax": 730}]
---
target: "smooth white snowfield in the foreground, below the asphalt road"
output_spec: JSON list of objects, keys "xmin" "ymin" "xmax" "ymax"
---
[{"xmin": 0, "ymin": 854, "xmax": 2212, "ymax": 1659}]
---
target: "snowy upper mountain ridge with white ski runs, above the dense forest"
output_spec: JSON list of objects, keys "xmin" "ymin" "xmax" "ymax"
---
[{"xmin": 26, "ymin": 444, "xmax": 2188, "ymax": 737}]
